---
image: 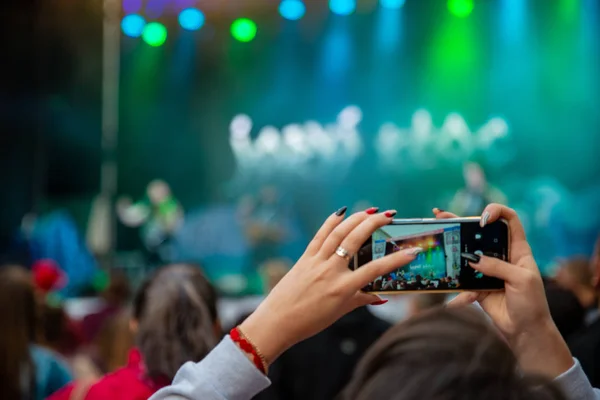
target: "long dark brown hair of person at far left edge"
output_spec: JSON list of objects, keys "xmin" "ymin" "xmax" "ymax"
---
[{"xmin": 0, "ymin": 266, "xmax": 37, "ymax": 399}]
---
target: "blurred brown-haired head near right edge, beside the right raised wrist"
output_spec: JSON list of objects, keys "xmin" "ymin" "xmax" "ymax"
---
[{"xmin": 555, "ymin": 257, "xmax": 596, "ymax": 308}]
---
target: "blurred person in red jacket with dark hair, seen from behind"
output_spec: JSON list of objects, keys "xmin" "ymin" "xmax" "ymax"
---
[{"xmin": 50, "ymin": 264, "xmax": 221, "ymax": 400}]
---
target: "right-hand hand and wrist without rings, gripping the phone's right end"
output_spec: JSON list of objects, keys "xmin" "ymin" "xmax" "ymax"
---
[{"xmin": 434, "ymin": 204, "xmax": 573, "ymax": 378}]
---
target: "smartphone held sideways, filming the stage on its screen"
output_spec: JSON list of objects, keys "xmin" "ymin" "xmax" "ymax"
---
[{"xmin": 350, "ymin": 217, "xmax": 510, "ymax": 294}]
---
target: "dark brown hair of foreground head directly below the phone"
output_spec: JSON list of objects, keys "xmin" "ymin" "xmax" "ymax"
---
[{"xmin": 341, "ymin": 308, "xmax": 564, "ymax": 400}]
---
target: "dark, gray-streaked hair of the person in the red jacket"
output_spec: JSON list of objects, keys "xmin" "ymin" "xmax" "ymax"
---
[{"xmin": 133, "ymin": 264, "xmax": 218, "ymax": 381}]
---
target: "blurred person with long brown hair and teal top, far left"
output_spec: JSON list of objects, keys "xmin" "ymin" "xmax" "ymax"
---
[{"xmin": 0, "ymin": 266, "xmax": 71, "ymax": 400}]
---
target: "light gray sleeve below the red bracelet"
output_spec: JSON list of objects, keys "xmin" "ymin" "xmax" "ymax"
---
[{"xmin": 150, "ymin": 336, "xmax": 271, "ymax": 400}]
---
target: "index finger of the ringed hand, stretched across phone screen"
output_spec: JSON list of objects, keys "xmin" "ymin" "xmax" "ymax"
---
[{"xmin": 348, "ymin": 247, "xmax": 423, "ymax": 290}]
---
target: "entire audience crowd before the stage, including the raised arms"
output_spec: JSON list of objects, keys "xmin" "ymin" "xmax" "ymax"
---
[{"xmin": 0, "ymin": 204, "xmax": 600, "ymax": 400}]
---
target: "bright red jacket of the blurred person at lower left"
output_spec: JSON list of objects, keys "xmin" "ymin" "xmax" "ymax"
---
[{"xmin": 47, "ymin": 349, "xmax": 170, "ymax": 400}]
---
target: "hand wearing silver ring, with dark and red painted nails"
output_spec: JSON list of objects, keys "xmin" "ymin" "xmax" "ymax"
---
[{"xmin": 240, "ymin": 209, "xmax": 421, "ymax": 363}]
